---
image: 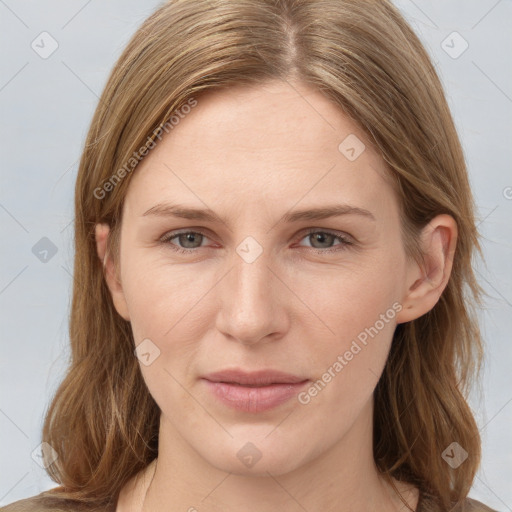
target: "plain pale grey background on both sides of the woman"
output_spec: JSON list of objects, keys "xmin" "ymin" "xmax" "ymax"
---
[{"xmin": 0, "ymin": 0, "xmax": 512, "ymax": 511}]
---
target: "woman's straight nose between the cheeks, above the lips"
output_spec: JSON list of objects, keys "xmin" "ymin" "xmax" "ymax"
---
[{"xmin": 216, "ymin": 250, "xmax": 291, "ymax": 345}]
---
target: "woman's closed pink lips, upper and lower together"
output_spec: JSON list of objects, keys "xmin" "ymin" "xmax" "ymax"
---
[{"xmin": 202, "ymin": 369, "xmax": 309, "ymax": 413}]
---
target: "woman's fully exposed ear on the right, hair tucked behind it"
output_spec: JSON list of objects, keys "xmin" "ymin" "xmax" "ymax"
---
[{"xmin": 396, "ymin": 214, "xmax": 458, "ymax": 324}]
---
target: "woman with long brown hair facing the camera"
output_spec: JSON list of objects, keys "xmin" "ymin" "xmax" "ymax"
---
[{"xmin": 3, "ymin": 0, "xmax": 491, "ymax": 512}]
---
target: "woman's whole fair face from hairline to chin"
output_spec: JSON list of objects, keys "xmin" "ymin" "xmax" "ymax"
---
[{"xmin": 98, "ymin": 82, "xmax": 442, "ymax": 474}]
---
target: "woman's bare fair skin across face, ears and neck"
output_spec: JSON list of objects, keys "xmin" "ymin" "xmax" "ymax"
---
[{"xmin": 96, "ymin": 81, "xmax": 457, "ymax": 512}]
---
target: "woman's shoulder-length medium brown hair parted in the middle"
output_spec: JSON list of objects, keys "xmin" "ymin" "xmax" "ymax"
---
[{"xmin": 39, "ymin": 0, "xmax": 483, "ymax": 509}]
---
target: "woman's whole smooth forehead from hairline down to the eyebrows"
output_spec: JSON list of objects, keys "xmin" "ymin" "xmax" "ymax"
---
[{"xmin": 126, "ymin": 81, "xmax": 392, "ymax": 218}]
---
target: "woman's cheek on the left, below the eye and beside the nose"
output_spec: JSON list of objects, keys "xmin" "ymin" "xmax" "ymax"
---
[{"xmin": 123, "ymin": 258, "xmax": 213, "ymax": 410}]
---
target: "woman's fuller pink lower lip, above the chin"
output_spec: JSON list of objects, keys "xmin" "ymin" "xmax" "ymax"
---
[{"xmin": 203, "ymin": 379, "xmax": 308, "ymax": 412}]
